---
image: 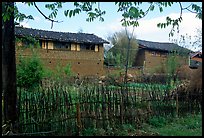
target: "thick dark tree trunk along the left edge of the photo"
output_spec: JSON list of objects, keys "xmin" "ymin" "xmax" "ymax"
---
[{"xmin": 2, "ymin": 2, "xmax": 17, "ymax": 124}]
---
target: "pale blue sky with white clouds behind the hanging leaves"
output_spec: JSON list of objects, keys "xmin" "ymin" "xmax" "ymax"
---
[{"xmin": 16, "ymin": 2, "xmax": 202, "ymax": 51}]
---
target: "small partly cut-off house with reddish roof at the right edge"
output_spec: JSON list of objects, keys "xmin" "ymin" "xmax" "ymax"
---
[{"xmin": 189, "ymin": 51, "xmax": 202, "ymax": 69}]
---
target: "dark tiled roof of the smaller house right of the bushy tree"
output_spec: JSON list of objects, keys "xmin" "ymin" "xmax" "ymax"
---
[{"xmin": 137, "ymin": 39, "xmax": 191, "ymax": 52}]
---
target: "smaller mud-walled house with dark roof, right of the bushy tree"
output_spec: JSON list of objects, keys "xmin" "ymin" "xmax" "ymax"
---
[{"xmin": 134, "ymin": 40, "xmax": 190, "ymax": 71}]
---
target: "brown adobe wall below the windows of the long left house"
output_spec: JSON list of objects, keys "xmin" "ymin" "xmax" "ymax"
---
[{"xmin": 16, "ymin": 46, "xmax": 104, "ymax": 76}]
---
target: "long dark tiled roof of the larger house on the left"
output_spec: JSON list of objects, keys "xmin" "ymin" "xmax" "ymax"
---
[{"xmin": 15, "ymin": 27, "xmax": 109, "ymax": 44}]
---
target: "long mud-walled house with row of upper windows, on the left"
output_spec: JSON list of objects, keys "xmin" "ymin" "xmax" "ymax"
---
[{"xmin": 15, "ymin": 27, "xmax": 109, "ymax": 76}]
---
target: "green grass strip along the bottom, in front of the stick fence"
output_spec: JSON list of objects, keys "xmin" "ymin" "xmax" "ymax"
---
[{"xmin": 82, "ymin": 114, "xmax": 202, "ymax": 136}]
